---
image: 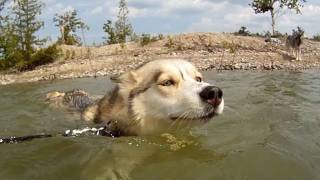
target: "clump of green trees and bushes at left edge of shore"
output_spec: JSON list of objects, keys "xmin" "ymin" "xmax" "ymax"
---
[{"xmin": 0, "ymin": 0, "xmax": 59, "ymax": 71}]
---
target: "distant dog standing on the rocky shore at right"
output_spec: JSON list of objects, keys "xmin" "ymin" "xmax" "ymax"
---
[{"xmin": 286, "ymin": 27, "xmax": 304, "ymax": 61}]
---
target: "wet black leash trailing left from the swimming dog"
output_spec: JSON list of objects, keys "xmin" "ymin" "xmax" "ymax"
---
[{"xmin": 0, "ymin": 126, "xmax": 117, "ymax": 144}]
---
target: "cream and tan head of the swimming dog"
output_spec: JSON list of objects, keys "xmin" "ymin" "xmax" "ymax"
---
[{"xmin": 111, "ymin": 60, "xmax": 224, "ymax": 134}]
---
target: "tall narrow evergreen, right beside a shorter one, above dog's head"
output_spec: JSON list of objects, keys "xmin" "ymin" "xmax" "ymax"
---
[{"xmin": 115, "ymin": 0, "xmax": 133, "ymax": 43}]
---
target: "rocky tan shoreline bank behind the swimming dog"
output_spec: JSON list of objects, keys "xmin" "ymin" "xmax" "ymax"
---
[{"xmin": 0, "ymin": 33, "xmax": 320, "ymax": 85}]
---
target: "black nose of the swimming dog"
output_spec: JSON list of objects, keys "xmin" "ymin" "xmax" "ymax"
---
[{"xmin": 200, "ymin": 86, "xmax": 223, "ymax": 107}]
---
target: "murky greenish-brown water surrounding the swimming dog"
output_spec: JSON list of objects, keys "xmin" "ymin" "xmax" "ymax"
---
[{"xmin": 0, "ymin": 71, "xmax": 320, "ymax": 180}]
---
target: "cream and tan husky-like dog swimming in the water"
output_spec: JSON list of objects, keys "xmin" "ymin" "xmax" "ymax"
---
[{"xmin": 47, "ymin": 59, "xmax": 224, "ymax": 136}]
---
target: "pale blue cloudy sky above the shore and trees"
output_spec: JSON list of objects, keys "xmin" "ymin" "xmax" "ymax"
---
[{"xmin": 36, "ymin": 0, "xmax": 320, "ymax": 44}]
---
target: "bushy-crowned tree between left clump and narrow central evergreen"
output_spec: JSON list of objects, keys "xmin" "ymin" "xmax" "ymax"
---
[{"xmin": 53, "ymin": 10, "xmax": 89, "ymax": 45}]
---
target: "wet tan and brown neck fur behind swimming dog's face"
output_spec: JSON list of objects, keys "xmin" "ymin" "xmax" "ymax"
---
[{"xmin": 94, "ymin": 86, "xmax": 172, "ymax": 136}]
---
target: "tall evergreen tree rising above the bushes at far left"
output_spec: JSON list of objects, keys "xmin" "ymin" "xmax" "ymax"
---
[{"xmin": 13, "ymin": 0, "xmax": 45, "ymax": 61}]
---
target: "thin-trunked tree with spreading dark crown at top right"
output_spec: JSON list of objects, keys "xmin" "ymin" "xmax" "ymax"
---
[{"xmin": 249, "ymin": 0, "xmax": 306, "ymax": 35}]
